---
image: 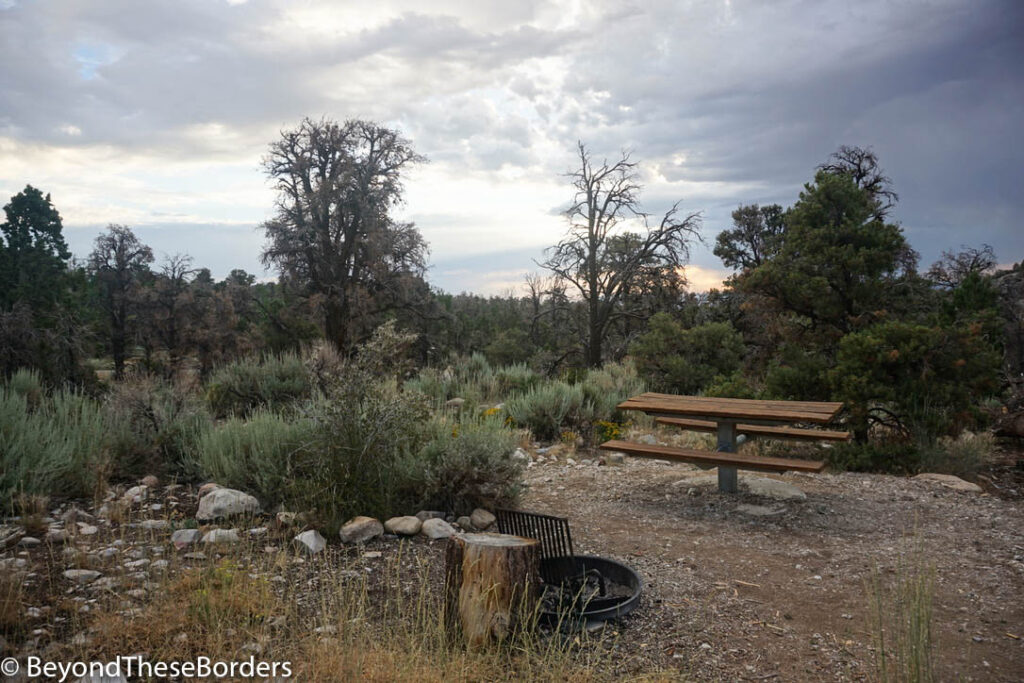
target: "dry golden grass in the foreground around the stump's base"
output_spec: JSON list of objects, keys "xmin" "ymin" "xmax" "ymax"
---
[{"xmin": 59, "ymin": 549, "xmax": 608, "ymax": 681}]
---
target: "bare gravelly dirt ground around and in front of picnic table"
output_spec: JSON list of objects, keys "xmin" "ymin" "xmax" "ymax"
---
[{"xmin": 522, "ymin": 440, "xmax": 1024, "ymax": 681}]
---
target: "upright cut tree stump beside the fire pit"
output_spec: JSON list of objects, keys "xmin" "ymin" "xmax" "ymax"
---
[{"xmin": 445, "ymin": 533, "xmax": 541, "ymax": 648}]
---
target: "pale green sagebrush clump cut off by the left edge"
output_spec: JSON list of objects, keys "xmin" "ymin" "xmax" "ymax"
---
[{"xmin": 0, "ymin": 377, "xmax": 118, "ymax": 509}]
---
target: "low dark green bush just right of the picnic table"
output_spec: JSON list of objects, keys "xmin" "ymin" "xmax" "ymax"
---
[{"xmin": 829, "ymin": 323, "xmax": 999, "ymax": 444}]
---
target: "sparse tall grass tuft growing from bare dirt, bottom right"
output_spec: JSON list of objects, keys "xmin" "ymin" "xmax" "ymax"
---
[{"xmin": 867, "ymin": 540, "xmax": 935, "ymax": 683}]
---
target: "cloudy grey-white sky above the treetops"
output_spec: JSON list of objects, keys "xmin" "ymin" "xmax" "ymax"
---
[{"xmin": 0, "ymin": 0, "xmax": 1024, "ymax": 293}]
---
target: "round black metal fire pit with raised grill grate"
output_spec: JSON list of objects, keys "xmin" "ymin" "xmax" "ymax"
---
[{"xmin": 497, "ymin": 510, "xmax": 643, "ymax": 626}]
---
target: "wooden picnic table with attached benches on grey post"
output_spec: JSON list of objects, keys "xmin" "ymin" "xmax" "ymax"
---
[{"xmin": 600, "ymin": 392, "xmax": 850, "ymax": 493}]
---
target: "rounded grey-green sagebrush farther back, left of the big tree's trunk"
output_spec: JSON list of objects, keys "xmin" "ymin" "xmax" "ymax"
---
[{"xmin": 206, "ymin": 352, "xmax": 312, "ymax": 418}]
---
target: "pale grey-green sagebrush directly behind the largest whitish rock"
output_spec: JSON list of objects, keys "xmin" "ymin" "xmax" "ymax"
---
[{"xmin": 194, "ymin": 409, "xmax": 312, "ymax": 504}]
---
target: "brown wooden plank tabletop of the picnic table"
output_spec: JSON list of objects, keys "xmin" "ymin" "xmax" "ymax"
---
[{"xmin": 618, "ymin": 391, "xmax": 843, "ymax": 425}]
